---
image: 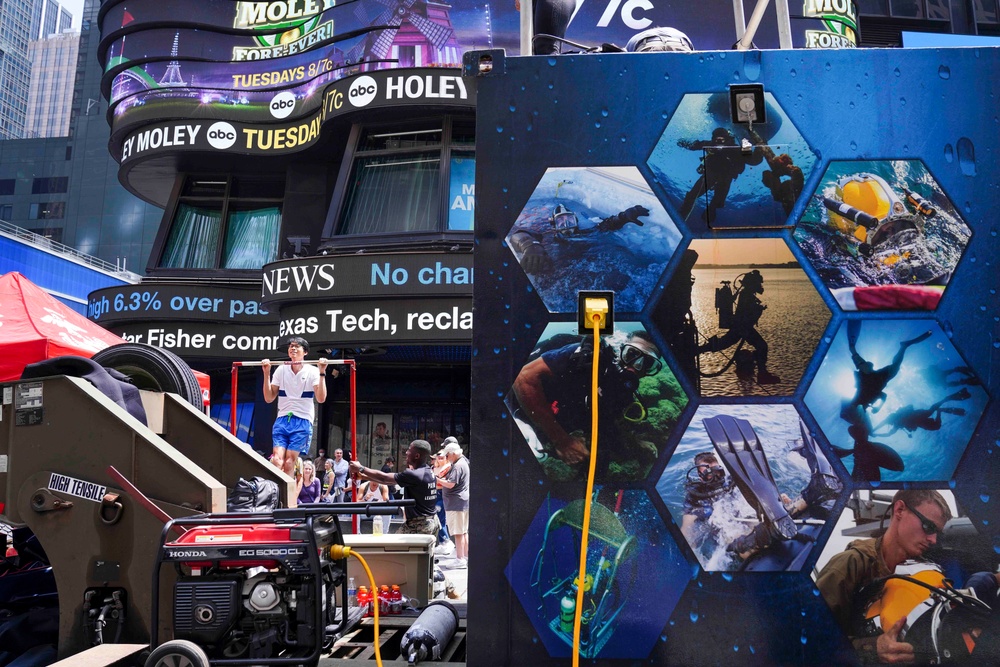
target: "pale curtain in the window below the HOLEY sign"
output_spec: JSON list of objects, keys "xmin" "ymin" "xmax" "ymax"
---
[{"xmin": 341, "ymin": 151, "xmax": 441, "ymax": 234}]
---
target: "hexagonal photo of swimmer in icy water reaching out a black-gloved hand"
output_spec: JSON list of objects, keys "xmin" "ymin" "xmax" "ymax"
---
[{"xmin": 506, "ymin": 167, "xmax": 681, "ymax": 313}]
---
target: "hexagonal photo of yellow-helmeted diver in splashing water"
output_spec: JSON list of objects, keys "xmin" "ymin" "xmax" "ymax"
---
[{"xmin": 794, "ymin": 160, "xmax": 972, "ymax": 310}]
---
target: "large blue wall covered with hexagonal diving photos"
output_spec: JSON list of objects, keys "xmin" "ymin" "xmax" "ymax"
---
[{"xmin": 465, "ymin": 48, "xmax": 1000, "ymax": 665}]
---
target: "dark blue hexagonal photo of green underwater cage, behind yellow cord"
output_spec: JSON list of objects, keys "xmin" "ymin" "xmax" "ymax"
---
[{"xmin": 504, "ymin": 487, "xmax": 690, "ymax": 659}]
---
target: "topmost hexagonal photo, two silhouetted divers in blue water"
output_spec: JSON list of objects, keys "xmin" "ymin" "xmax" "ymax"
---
[{"xmin": 649, "ymin": 93, "xmax": 816, "ymax": 228}]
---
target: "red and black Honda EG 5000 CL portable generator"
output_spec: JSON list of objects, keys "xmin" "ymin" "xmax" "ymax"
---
[{"xmin": 146, "ymin": 501, "xmax": 412, "ymax": 667}]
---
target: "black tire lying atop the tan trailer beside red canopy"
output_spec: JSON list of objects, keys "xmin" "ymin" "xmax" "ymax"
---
[{"xmin": 93, "ymin": 343, "xmax": 205, "ymax": 410}]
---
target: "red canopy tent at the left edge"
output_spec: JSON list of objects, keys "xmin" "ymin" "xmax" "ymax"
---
[{"xmin": 0, "ymin": 271, "xmax": 209, "ymax": 402}]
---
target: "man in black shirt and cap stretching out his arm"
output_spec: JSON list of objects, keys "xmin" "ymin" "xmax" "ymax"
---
[{"xmin": 351, "ymin": 440, "xmax": 441, "ymax": 535}]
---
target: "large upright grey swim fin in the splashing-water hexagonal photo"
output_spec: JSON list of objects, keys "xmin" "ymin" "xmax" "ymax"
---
[{"xmin": 702, "ymin": 415, "xmax": 798, "ymax": 540}]
